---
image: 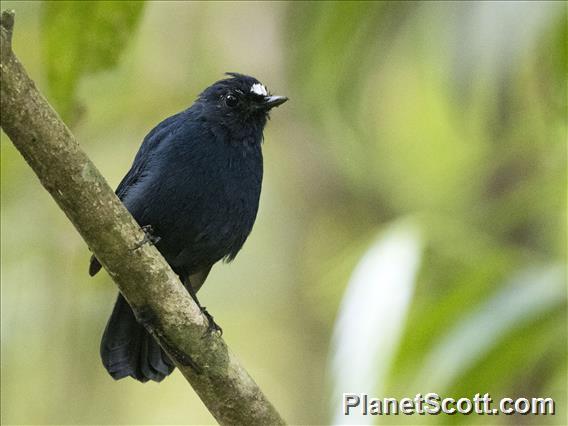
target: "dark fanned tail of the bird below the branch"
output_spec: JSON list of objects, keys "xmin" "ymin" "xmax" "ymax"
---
[{"xmin": 101, "ymin": 294, "xmax": 175, "ymax": 382}]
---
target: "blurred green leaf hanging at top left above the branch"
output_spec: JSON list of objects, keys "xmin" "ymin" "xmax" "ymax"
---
[{"xmin": 41, "ymin": 1, "xmax": 144, "ymax": 122}]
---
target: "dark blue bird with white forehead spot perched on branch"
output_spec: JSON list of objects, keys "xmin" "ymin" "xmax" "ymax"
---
[{"xmin": 89, "ymin": 72, "xmax": 288, "ymax": 383}]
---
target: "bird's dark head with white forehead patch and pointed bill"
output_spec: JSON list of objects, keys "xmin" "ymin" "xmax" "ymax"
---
[{"xmin": 198, "ymin": 72, "xmax": 288, "ymax": 139}]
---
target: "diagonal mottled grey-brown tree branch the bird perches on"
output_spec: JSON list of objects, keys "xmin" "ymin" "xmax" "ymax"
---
[{"xmin": 0, "ymin": 11, "xmax": 284, "ymax": 425}]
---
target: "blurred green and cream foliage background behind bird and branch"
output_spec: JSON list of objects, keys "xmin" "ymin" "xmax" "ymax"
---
[{"xmin": 1, "ymin": 1, "xmax": 568, "ymax": 424}]
